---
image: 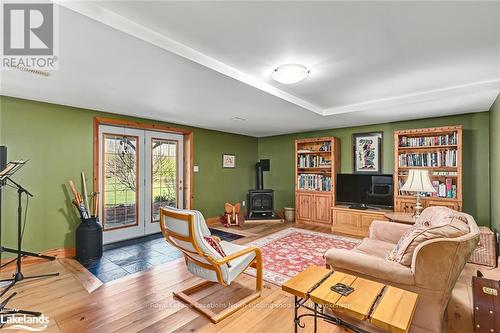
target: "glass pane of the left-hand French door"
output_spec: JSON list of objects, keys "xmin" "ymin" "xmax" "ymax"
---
[{"xmin": 103, "ymin": 134, "xmax": 138, "ymax": 229}]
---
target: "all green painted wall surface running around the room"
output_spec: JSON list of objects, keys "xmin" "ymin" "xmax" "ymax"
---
[{"xmin": 0, "ymin": 96, "xmax": 492, "ymax": 251}]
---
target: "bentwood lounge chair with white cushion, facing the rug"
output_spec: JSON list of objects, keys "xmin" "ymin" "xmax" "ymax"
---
[{"xmin": 160, "ymin": 208, "xmax": 262, "ymax": 323}]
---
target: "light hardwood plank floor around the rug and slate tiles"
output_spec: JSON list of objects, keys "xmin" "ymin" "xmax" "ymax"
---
[{"xmin": 0, "ymin": 223, "xmax": 500, "ymax": 333}]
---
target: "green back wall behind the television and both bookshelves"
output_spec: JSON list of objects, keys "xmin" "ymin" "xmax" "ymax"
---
[{"xmin": 259, "ymin": 112, "xmax": 490, "ymax": 225}]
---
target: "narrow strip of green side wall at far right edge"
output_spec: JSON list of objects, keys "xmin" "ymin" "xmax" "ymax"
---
[{"xmin": 490, "ymin": 94, "xmax": 500, "ymax": 232}]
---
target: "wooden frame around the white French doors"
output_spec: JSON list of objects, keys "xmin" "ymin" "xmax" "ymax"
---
[{"xmin": 93, "ymin": 117, "xmax": 194, "ymax": 209}]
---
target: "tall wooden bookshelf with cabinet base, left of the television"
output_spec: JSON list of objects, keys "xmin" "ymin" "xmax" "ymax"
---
[{"xmin": 295, "ymin": 137, "xmax": 340, "ymax": 226}]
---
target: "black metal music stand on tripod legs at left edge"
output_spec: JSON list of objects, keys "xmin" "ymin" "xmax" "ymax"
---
[{"xmin": 0, "ymin": 177, "xmax": 59, "ymax": 298}]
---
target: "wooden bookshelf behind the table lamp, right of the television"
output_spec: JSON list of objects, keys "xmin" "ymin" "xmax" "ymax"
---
[{"xmin": 394, "ymin": 126, "xmax": 463, "ymax": 213}]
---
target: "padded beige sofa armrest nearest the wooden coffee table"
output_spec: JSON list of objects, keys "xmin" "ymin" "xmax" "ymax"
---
[{"xmin": 325, "ymin": 248, "xmax": 415, "ymax": 285}]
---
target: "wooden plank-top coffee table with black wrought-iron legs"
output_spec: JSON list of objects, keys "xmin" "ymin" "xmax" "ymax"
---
[{"xmin": 282, "ymin": 266, "xmax": 418, "ymax": 333}]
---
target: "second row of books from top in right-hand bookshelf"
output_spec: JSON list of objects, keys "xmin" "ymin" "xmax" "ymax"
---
[{"xmin": 399, "ymin": 149, "xmax": 457, "ymax": 167}]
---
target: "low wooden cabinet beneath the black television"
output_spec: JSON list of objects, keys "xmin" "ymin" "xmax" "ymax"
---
[{"xmin": 332, "ymin": 206, "xmax": 389, "ymax": 237}]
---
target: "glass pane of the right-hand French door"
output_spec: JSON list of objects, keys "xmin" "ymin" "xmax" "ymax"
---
[{"xmin": 151, "ymin": 139, "xmax": 178, "ymax": 222}]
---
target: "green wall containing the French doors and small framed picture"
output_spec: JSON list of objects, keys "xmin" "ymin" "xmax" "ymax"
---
[{"xmin": 0, "ymin": 96, "xmax": 258, "ymax": 251}]
